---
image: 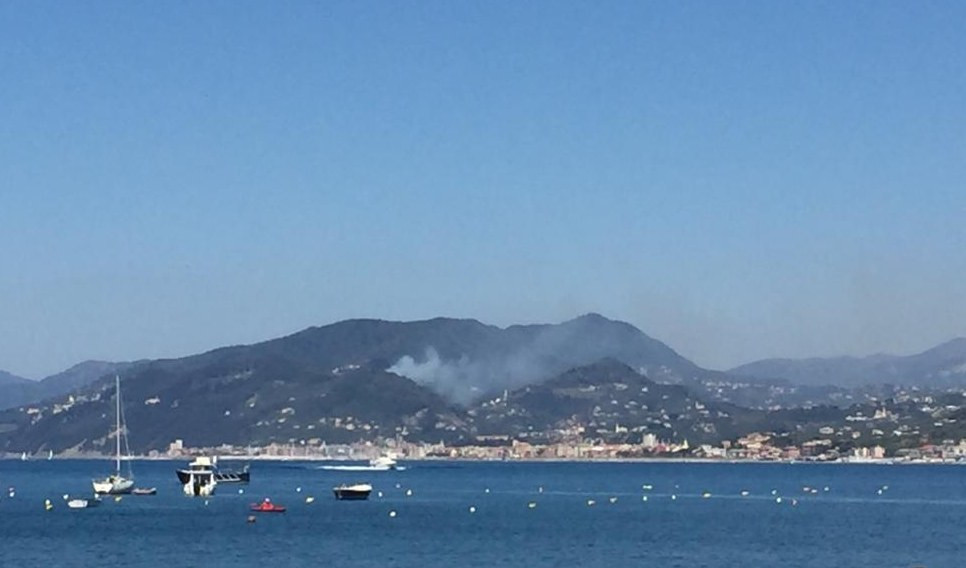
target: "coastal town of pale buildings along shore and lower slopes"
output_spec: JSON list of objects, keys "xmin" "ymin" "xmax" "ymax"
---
[{"xmin": 7, "ymin": 368, "xmax": 966, "ymax": 463}]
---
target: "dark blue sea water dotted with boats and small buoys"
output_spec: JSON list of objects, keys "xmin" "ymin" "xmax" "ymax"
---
[{"xmin": 0, "ymin": 460, "xmax": 966, "ymax": 568}]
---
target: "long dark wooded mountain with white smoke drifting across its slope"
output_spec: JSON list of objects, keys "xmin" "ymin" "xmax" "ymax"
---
[{"xmin": 0, "ymin": 314, "xmax": 728, "ymax": 452}]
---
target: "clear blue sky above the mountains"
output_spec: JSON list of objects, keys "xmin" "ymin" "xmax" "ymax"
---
[{"xmin": 0, "ymin": 1, "xmax": 966, "ymax": 378}]
